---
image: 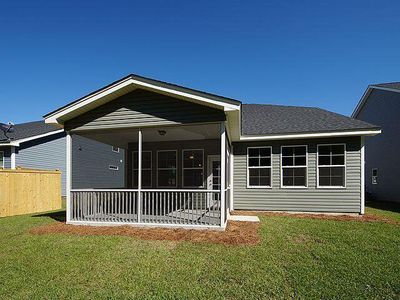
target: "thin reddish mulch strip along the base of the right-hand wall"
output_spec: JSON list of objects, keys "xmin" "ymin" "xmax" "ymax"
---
[{"xmin": 232, "ymin": 211, "xmax": 400, "ymax": 225}]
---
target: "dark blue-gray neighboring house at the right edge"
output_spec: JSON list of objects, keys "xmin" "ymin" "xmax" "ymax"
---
[{"xmin": 352, "ymin": 82, "xmax": 400, "ymax": 202}]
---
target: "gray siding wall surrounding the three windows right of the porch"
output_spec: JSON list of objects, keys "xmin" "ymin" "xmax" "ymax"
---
[{"xmin": 233, "ymin": 137, "xmax": 361, "ymax": 213}]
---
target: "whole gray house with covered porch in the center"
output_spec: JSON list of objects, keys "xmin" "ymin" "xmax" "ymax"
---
[{"xmin": 44, "ymin": 75, "xmax": 380, "ymax": 228}]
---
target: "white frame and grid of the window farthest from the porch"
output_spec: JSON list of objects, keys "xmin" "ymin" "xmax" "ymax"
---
[{"xmin": 317, "ymin": 144, "xmax": 346, "ymax": 188}]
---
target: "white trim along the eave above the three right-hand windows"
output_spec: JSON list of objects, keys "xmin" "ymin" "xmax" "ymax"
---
[{"xmin": 240, "ymin": 129, "xmax": 382, "ymax": 141}]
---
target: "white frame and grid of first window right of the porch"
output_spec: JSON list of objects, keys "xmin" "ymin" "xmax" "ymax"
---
[{"xmin": 247, "ymin": 146, "xmax": 272, "ymax": 188}]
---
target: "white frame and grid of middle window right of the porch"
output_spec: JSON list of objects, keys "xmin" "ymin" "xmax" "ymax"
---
[{"xmin": 281, "ymin": 145, "xmax": 308, "ymax": 188}]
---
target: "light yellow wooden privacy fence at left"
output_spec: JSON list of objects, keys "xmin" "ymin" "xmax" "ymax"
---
[{"xmin": 0, "ymin": 169, "xmax": 61, "ymax": 217}]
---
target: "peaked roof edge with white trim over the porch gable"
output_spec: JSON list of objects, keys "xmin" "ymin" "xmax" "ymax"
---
[{"xmin": 43, "ymin": 74, "xmax": 241, "ymax": 123}]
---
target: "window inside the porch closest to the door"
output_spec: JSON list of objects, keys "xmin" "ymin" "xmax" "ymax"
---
[{"xmin": 182, "ymin": 149, "xmax": 204, "ymax": 188}]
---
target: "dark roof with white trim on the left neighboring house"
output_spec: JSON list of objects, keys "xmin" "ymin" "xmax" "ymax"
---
[{"xmin": 0, "ymin": 121, "xmax": 63, "ymax": 146}]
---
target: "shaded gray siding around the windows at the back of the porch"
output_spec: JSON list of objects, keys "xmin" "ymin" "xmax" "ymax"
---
[{"xmin": 127, "ymin": 140, "xmax": 221, "ymax": 189}]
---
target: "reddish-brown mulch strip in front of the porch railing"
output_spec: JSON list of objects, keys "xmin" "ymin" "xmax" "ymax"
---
[{"xmin": 30, "ymin": 221, "xmax": 260, "ymax": 245}]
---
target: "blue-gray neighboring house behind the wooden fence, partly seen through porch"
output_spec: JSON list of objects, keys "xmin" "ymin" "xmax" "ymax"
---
[{"xmin": 0, "ymin": 121, "xmax": 125, "ymax": 196}]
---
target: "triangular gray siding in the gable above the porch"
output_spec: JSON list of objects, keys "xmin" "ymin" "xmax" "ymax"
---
[{"xmin": 65, "ymin": 90, "xmax": 225, "ymax": 130}]
